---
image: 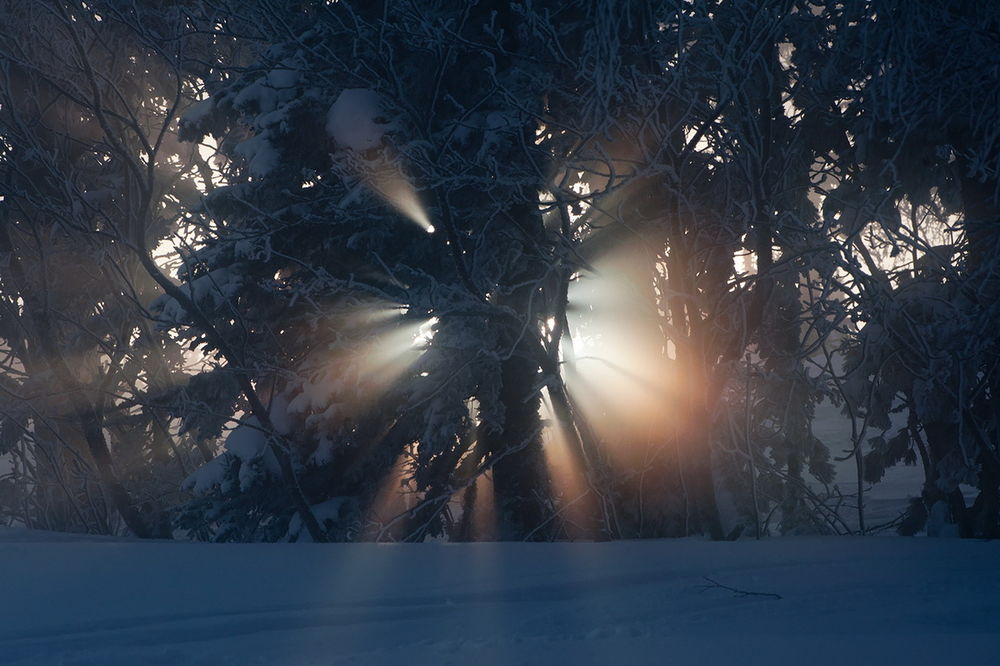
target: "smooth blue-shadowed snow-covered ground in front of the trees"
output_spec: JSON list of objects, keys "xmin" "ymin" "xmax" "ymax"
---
[{"xmin": 0, "ymin": 529, "xmax": 1000, "ymax": 666}]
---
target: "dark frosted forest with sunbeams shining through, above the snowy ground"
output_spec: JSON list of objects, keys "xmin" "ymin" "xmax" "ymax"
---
[{"xmin": 0, "ymin": 0, "xmax": 1000, "ymax": 541}]
